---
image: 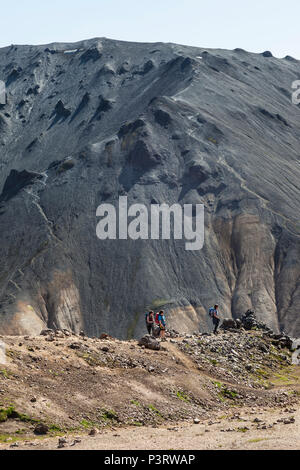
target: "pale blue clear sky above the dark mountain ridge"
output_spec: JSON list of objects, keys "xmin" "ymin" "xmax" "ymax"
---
[{"xmin": 0, "ymin": 0, "xmax": 300, "ymax": 59}]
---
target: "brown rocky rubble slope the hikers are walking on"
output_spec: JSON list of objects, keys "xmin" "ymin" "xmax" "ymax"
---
[{"xmin": 0, "ymin": 329, "xmax": 300, "ymax": 448}]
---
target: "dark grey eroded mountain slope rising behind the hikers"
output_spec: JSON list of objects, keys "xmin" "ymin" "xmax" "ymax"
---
[{"xmin": 0, "ymin": 39, "xmax": 300, "ymax": 338}]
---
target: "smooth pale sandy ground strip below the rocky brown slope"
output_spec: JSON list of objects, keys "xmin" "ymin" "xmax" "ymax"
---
[{"xmin": 0, "ymin": 408, "xmax": 300, "ymax": 450}]
